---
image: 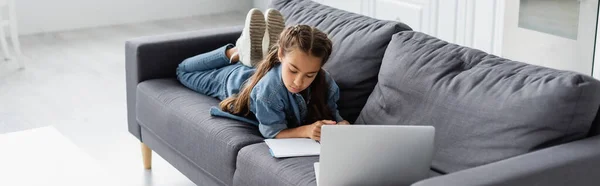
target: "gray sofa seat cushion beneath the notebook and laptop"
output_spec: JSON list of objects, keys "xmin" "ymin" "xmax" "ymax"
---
[{"xmin": 233, "ymin": 143, "xmax": 440, "ymax": 186}]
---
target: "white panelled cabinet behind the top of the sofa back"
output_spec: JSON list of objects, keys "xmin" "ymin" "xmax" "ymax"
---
[{"xmin": 255, "ymin": 0, "xmax": 506, "ymax": 55}]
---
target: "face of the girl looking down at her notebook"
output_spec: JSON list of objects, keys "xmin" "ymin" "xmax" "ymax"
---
[{"xmin": 278, "ymin": 49, "xmax": 322, "ymax": 93}]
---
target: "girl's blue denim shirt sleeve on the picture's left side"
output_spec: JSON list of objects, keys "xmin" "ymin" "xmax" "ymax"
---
[{"xmin": 250, "ymin": 87, "xmax": 287, "ymax": 139}]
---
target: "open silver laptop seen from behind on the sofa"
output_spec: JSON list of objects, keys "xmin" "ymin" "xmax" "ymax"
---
[{"xmin": 314, "ymin": 125, "xmax": 435, "ymax": 186}]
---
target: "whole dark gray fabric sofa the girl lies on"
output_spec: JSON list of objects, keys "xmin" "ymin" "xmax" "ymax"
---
[{"xmin": 126, "ymin": 0, "xmax": 600, "ymax": 186}]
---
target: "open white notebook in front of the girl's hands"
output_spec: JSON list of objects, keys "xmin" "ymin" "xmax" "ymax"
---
[{"xmin": 265, "ymin": 138, "xmax": 321, "ymax": 158}]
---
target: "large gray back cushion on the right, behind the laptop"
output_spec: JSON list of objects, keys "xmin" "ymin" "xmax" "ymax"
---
[{"xmin": 357, "ymin": 31, "xmax": 600, "ymax": 173}]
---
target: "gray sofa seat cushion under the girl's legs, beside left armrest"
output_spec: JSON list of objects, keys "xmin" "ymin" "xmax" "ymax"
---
[{"xmin": 136, "ymin": 78, "xmax": 264, "ymax": 185}]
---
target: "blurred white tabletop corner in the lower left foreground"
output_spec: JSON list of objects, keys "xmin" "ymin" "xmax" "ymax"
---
[{"xmin": 0, "ymin": 126, "xmax": 125, "ymax": 186}]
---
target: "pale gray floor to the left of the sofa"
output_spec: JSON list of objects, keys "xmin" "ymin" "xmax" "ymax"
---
[{"xmin": 0, "ymin": 13, "xmax": 245, "ymax": 186}]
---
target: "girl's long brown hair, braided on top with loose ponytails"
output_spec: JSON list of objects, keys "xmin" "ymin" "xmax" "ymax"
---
[{"xmin": 219, "ymin": 25, "xmax": 335, "ymax": 123}]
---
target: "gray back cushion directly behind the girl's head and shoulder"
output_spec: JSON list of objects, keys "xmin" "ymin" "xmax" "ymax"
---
[{"xmin": 271, "ymin": 0, "xmax": 410, "ymax": 122}]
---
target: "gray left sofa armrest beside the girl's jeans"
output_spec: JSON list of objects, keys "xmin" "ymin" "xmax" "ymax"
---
[{"xmin": 125, "ymin": 26, "xmax": 242, "ymax": 141}]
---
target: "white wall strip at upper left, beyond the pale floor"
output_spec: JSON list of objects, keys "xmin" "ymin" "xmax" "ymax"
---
[{"xmin": 15, "ymin": 0, "xmax": 252, "ymax": 35}]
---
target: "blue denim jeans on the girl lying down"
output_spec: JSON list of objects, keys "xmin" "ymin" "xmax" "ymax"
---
[{"xmin": 177, "ymin": 44, "xmax": 254, "ymax": 100}]
